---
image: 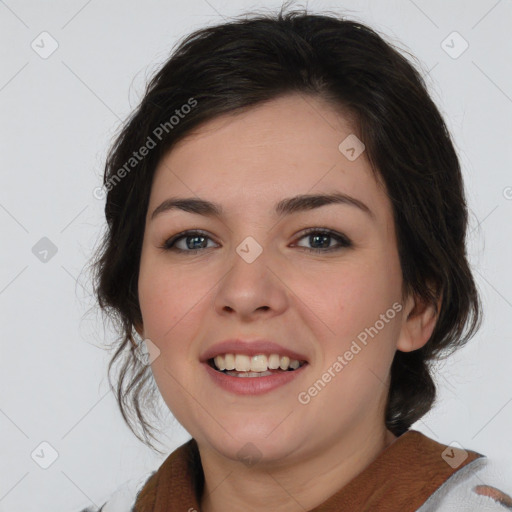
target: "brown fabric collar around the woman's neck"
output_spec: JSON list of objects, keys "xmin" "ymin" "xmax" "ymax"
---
[{"xmin": 132, "ymin": 430, "xmax": 485, "ymax": 512}]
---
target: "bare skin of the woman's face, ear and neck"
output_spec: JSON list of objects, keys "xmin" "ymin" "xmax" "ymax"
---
[{"xmin": 137, "ymin": 94, "xmax": 436, "ymax": 512}]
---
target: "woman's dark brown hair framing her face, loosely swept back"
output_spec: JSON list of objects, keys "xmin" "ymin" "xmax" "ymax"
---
[{"xmin": 86, "ymin": 3, "xmax": 482, "ymax": 452}]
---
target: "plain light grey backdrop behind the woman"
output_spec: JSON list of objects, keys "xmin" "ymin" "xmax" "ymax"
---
[{"xmin": 0, "ymin": 0, "xmax": 512, "ymax": 512}]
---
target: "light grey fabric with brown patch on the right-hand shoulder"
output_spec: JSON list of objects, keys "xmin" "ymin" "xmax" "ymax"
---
[{"xmin": 417, "ymin": 457, "xmax": 512, "ymax": 512}]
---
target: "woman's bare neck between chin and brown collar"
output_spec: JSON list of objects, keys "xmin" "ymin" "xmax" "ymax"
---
[{"xmin": 199, "ymin": 427, "xmax": 397, "ymax": 512}]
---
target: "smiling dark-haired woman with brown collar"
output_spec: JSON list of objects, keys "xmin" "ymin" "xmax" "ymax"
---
[{"xmin": 82, "ymin": 5, "xmax": 512, "ymax": 512}]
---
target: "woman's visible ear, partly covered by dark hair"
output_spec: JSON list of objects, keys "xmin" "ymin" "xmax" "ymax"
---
[{"xmin": 396, "ymin": 286, "xmax": 442, "ymax": 352}]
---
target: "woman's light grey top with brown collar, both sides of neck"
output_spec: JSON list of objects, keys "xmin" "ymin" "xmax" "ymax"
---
[{"xmin": 77, "ymin": 430, "xmax": 512, "ymax": 512}]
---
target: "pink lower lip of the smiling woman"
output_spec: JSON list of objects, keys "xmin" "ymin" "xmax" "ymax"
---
[{"xmin": 203, "ymin": 363, "xmax": 308, "ymax": 395}]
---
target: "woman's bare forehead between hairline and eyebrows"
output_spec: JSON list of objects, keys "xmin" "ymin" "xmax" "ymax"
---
[{"xmin": 150, "ymin": 94, "xmax": 390, "ymax": 224}]
